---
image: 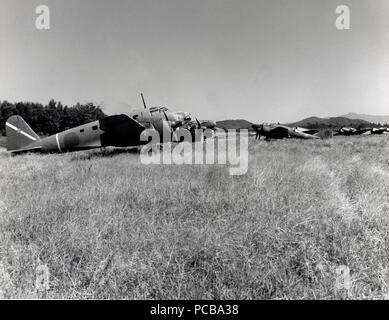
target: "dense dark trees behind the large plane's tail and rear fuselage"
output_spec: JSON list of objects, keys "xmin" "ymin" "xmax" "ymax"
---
[{"xmin": 0, "ymin": 100, "xmax": 106, "ymax": 136}]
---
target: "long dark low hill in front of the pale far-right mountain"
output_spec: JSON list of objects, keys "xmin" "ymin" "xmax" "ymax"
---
[{"xmin": 287, "ymin": 117, "xmax": 375, "ymax": 129}]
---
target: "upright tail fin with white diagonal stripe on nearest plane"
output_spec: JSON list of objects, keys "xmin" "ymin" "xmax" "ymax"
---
[{"xmin": 5, "ymin": 116, "xmax": 40, "ymax": 152}]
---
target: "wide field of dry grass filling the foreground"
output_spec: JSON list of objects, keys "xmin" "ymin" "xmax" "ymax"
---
[{"xmin": 0, "ymin": 136, "xmax": 389, "ymax": 299}]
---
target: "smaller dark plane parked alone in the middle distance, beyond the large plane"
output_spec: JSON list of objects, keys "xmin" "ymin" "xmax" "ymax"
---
[{"xmin": 252, "ymin": 124, "xmax": 320, "ymax": 140}]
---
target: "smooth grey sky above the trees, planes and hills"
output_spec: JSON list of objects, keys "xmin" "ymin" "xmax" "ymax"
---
[{"xmin": 0, "ymin": 0, "xmax": 389, "ymax": 122}]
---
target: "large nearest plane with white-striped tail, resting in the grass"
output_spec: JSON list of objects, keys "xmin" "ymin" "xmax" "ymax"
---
[{"xmin": 6, "ymin": 94, "xmax": 212, "ymax": 153}]
